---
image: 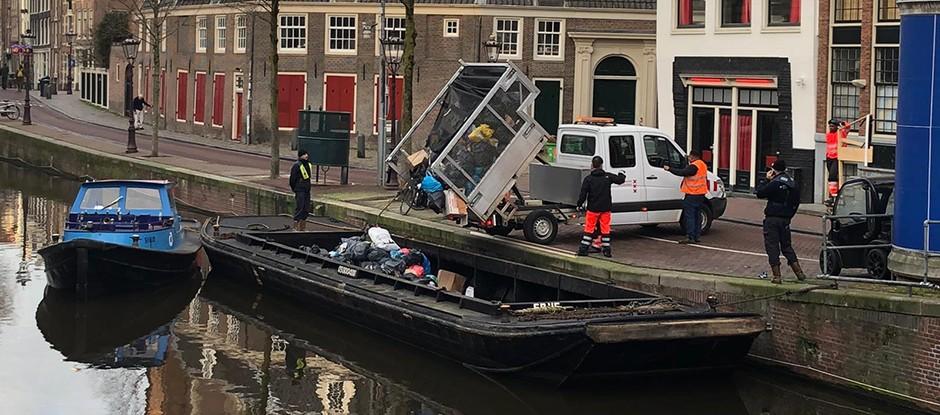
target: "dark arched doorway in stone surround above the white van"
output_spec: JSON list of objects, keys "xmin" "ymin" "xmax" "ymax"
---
[{"xmin": 592, "ymin": 56, "xmax": 636, "ymax": 124}]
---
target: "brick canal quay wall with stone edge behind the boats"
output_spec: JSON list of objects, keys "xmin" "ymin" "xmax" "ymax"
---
[{"xmin": 0, "ymin": 126, "xmax": 940, "ymax": 411}]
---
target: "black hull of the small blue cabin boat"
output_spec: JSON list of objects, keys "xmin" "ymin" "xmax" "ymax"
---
[{"xmin": 39, "ymin": 236, "xmax": 201, "ymax": 295}]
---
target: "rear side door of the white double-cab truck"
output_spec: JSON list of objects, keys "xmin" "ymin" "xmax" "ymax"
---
[{"xmin": 606, "ymin": 135, "xmax": 647, "ymax": 225}]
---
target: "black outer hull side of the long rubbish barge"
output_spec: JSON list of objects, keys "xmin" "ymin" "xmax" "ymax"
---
[{"xmin": 203, "ymin": 221, "xmax": 764, "ymax": 383}]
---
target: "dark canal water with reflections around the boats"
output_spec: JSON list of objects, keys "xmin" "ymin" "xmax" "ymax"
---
[{"xmin": 0, "ymin": 163, "xmax": 913, "ymax": 415}]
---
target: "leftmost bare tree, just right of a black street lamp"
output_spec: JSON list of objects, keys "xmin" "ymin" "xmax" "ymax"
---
[{"xmin": 118, "ymin": 0, "xmax": 179, "ymax": 157}]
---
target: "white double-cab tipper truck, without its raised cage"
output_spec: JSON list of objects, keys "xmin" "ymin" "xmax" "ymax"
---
[{"xmin": 483, "ymin": 119, "xmax": 727, "ymax": 244}]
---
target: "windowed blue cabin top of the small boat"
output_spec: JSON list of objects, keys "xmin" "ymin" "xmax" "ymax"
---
[{"xmin": 69, "ymin": 180, "xmax": 176, "ymax": 217}]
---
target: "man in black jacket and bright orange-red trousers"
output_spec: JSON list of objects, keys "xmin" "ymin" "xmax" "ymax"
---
[{"xmin": 577, "ymin": 156, "xmax": 627, "ymax": 258}]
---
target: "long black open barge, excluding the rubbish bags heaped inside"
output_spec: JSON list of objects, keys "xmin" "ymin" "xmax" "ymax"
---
[{"xmin": 202, "ymin": 216, "xmax": 766, "ymax": 382}]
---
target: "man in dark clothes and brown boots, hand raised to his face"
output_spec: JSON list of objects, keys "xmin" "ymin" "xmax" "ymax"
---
[{"xmin": 756, "ymin": 159, "xmax": 806, "ymax": 284}]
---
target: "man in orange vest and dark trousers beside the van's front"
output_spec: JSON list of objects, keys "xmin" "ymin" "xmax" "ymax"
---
[{"xmin": 663, "ymin": 150, "xmax": 708, "ymax": 244}]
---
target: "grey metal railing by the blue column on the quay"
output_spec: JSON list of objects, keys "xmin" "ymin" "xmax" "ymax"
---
[{"xmin": 819, "ymin": 213, "xmax": 940, "ymax": 295}]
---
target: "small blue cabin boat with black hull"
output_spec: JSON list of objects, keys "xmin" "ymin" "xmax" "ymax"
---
[{"xmin": 39, "ymin": 180, "xmax": 208, "ymax": 294}]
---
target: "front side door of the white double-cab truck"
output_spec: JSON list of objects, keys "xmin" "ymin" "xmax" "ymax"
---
[{"xmin": 643, "ymin": 135, "xmax": 688, "ymax": 223}]
